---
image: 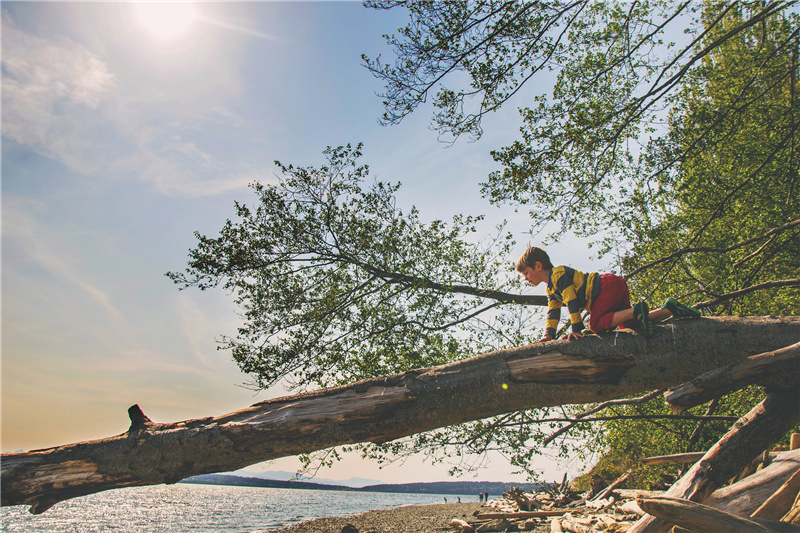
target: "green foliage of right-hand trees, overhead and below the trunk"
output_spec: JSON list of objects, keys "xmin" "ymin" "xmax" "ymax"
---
[{"xmin": 364, "ymin": 1, "xmax": 800, "ymax": 483}]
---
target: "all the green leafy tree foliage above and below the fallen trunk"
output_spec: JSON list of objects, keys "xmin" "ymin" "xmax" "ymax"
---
[{"xmin": 175, "ymin": 0, "xmax": 800, "ymax": 483}]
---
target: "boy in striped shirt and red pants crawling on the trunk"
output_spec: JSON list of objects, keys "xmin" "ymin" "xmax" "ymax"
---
[{"xmin": 517, "ymin": 247, "xmax": 701, "ymax": 342}]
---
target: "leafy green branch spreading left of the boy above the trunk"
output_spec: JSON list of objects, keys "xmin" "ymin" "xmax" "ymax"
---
[{"xmin": 168, "ymin": 145, "xmax": 524, "ymax": 388}]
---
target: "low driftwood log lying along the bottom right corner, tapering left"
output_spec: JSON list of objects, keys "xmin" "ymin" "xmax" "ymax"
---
[{"xmin": 629, "ymin": 496, "xmax": 800, "ymax": 533}]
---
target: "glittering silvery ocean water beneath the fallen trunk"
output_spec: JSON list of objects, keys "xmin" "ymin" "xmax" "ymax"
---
[{"xmin": 0, "ymin": 483, "xmax": 477, "ymax": 533}]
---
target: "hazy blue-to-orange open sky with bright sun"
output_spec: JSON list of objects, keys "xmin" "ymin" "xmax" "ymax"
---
[{"xmin": 0, "ymin": 2, "xmax": 595, "ymax": 483}]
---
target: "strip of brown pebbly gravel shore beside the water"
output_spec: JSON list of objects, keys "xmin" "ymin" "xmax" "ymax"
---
[{"xmin": 262, "ymin": 503, "xmax": 483, "ymax": 533}]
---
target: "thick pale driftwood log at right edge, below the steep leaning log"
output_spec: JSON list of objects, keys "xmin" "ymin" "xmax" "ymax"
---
[{"xmin": 703, "ymin": 450, "xmax": 800, "ymax": 517}]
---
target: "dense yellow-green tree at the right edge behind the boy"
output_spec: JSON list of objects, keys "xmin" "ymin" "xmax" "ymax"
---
[{"xmin": 625, "ymin": 2, "xmax": 800, "ymax": 314}]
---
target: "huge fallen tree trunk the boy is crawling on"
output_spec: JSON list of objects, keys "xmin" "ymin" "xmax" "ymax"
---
[{"xmin": 0, "ymin": 317, "xmax": 800, "ymax": 513}]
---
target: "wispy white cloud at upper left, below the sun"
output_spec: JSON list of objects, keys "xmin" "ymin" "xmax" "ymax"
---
[{"xmin": 2, "ymin": 12, "xmax": 256, "ymax": 196}]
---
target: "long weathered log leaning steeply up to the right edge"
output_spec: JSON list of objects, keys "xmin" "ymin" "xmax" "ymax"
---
[{"xmin": 629, "ymin": 382, "xmax": 800, "ymax": 533}]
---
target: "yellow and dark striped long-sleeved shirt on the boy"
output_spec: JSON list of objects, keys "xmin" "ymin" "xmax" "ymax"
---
[{"xmin": 545, "ymin": 265, "xmax": 600, "ymax": 337}]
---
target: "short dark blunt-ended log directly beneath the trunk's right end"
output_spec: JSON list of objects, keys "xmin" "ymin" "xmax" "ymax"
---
[{"xmin": 664, "ymin": 342, "xmax": 800, "ymax": 412}]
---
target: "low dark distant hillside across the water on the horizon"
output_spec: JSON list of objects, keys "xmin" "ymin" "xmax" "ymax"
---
[{"xmin": 181, "ymin": 474, "xmax": 541, "ymax": 494}]
